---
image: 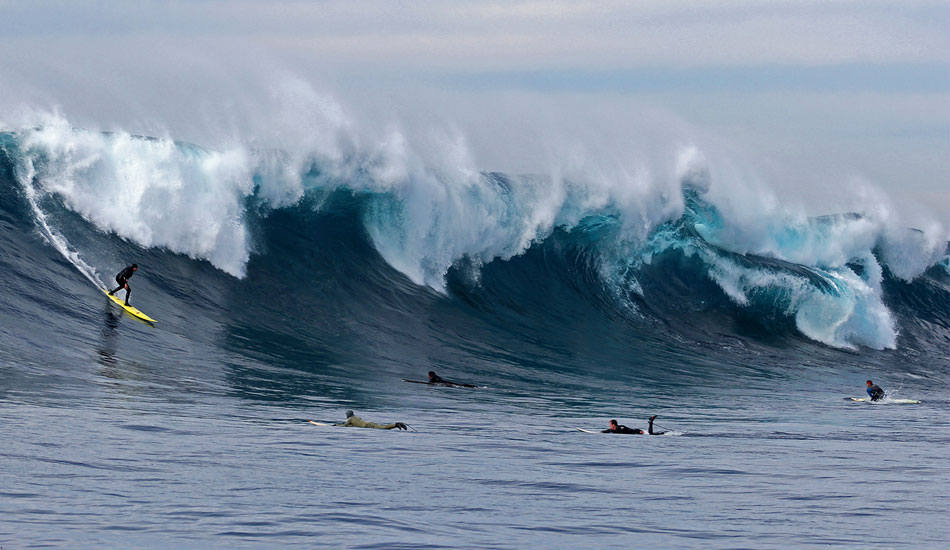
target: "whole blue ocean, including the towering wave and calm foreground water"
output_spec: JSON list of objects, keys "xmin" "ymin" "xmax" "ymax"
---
[{"xmin": 0, "ymin": 123, "xmax": 950, "ymax": 550}]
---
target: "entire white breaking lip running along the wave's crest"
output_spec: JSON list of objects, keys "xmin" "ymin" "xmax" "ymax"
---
[{"xmin": 5, "ymin": 103, "xmax": 946, "ymax": 349}]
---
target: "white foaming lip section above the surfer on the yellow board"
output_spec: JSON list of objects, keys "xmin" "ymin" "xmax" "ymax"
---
[{"xmin": 19, "ymin": 117, "xmax": 254, "ymax": 277}]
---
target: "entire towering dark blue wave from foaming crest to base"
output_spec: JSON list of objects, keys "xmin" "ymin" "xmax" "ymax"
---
[{"xmin": 0, "ymin": 119, "xmax": 950, "ymax": 392}]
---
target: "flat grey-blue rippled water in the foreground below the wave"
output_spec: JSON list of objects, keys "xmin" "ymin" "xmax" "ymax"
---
[{"xmin": 0, "ymin": 376, "xmax": 950, "ymax": 548}]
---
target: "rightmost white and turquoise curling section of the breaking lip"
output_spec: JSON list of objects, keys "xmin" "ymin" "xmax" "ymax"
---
[{"xmin": 695, "ymin": 183, "xmax": 946, "ymax": 349}]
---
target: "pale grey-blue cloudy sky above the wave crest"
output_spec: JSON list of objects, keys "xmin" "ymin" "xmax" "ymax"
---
[{"xmin": 0, "ymin": 0, "xmax": 950, "ymax": 227}]
